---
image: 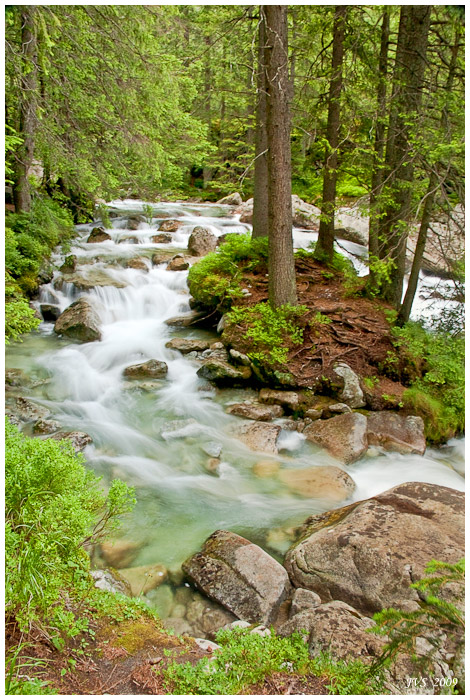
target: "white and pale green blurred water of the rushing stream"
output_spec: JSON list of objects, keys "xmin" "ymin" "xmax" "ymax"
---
[{"xmin": 6, "ymin": 200, "xmax": 464, "ymax": 624}]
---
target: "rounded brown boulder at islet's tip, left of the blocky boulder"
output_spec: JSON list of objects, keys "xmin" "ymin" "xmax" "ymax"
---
[{"xmin": 303, "ymin": 413, "xmax": 368, "ymax": 464}]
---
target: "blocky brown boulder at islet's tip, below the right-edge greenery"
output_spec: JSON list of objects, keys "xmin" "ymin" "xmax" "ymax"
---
[{"xmin": 367, "ymin": 411, "xmax": 426, "ymax": 455}]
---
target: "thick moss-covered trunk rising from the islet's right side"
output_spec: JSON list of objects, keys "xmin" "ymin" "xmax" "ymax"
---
[{"xmin": 379, "ymin": 5, "xmax": 431, "ymax": 309}]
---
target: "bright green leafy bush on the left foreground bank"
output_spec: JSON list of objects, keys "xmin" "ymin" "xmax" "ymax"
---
[{"xmin": 5, "ymin": 420, "xmax": 134, "ymax": 634}]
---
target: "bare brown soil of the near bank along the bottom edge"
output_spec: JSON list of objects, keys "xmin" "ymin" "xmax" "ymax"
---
[{"xmin": 6, "ymin": 618, "xmax": 328, "ymax": 695}]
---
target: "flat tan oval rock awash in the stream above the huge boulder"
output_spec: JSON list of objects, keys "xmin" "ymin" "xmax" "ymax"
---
[{"xmin": 279, "ymin": 467, "xmax": 356, "ymax": 503}]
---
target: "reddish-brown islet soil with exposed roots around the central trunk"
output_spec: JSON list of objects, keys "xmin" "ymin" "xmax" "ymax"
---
[{"xmin": 224, "ymin": 257, "xmax": 405, "ymax": 410}]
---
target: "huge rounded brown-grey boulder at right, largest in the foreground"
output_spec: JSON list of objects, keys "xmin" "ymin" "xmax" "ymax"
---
[{"xmin": 285, "ymin": 482, "xmax": 465, "ymax": 615}]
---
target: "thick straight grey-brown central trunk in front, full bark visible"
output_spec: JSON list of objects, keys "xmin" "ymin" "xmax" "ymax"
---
[{"xmin": 261, "ymin": 5, "xmax": 297, "ymax": 308}]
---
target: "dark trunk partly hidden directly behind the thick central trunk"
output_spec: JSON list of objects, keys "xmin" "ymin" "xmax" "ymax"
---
[{"xmin": 252, "ymin": 12, "xmax": 269, "ymax": 238}]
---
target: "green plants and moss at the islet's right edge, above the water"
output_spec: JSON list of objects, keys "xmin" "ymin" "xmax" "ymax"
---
[{"xmin": 393, "ymin": 322, "xmax": 465, "ymax": 443}]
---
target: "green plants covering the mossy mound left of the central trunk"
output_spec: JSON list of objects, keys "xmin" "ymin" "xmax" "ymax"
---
[{"xmin": 188, "ymin": 233, "xmax": 268, "ymax": 311}]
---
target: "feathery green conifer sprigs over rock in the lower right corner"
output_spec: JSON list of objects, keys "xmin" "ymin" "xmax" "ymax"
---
[{"xmin": 370, "ymin": 559, "xmax": 465, "ymax": 688}]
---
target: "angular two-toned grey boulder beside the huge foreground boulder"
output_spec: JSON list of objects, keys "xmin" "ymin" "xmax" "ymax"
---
[{"xmin": 182, "ymin": 530, "xmax": 290, "ymax": 624}]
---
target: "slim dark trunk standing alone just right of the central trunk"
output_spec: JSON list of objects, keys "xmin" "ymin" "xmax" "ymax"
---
[{"xmin": 315, "ymin": 5, "xmax": 348, "ymax": 261}]
